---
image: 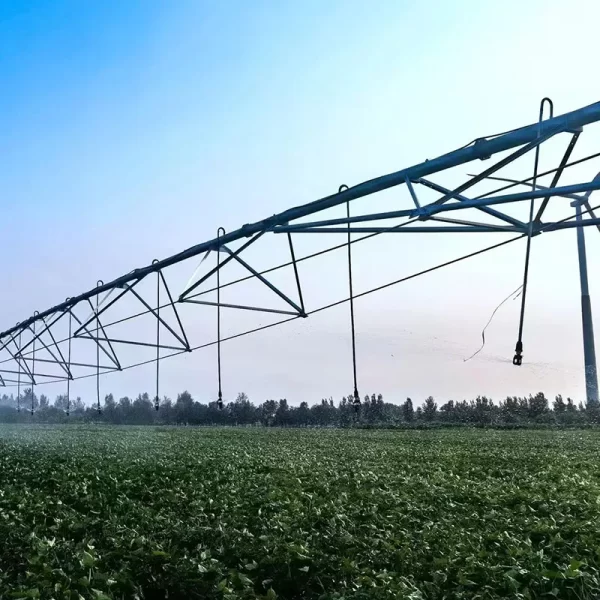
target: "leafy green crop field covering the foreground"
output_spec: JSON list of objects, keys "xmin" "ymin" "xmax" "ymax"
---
[{"xmin": 0, "ymin": 426, "xmax": 600, "ymax": 600}]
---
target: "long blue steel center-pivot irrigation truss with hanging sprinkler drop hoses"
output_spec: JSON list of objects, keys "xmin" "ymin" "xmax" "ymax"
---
[{"xmin": 0, "ymin": 98, "xmax": 600, "ymax": 414}]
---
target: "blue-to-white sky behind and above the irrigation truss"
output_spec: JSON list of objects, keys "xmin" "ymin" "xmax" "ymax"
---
[{"xmin": 0, "ymin": 0, "xmax": 600, "ymax": 404}]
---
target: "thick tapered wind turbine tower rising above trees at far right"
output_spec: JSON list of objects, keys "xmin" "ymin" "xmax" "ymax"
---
[{"xmin": 575, "ymin": 202, "xmax": 598, "ymax": 407}]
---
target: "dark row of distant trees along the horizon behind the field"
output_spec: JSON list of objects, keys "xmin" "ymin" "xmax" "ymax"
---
[{"xmin": 0, "ymin": 388, "xmax": 600, "ymax": 427}]
